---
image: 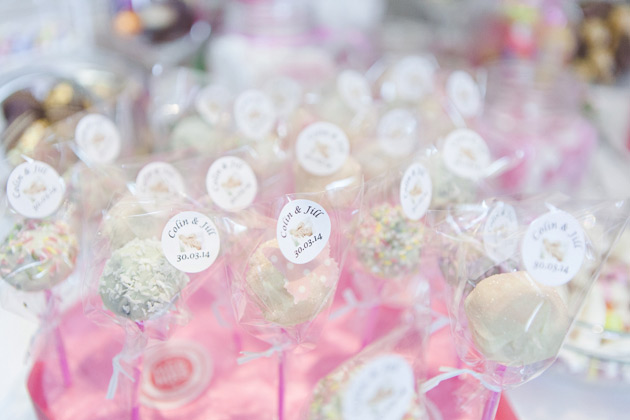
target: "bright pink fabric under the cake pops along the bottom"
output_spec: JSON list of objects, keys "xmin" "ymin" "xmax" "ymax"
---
[{"xmin": 28, "ymin": 263, "xmax": 504, "ymax": 420}]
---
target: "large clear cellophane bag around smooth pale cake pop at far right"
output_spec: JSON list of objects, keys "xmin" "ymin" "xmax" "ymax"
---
[{"xmin": 435, "ymin": 196, "xmax": 628, "ymax": 388}]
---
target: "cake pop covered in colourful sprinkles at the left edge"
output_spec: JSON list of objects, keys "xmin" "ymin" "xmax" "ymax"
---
[{"xmin": 0, "ymin": 219, "xmax": 79, "ymax": 292}]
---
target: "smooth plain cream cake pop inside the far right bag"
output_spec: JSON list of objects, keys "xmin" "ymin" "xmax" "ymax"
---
[{"xmin": 465, "ymin": 271, "xmax": 569, "ymax": 366}]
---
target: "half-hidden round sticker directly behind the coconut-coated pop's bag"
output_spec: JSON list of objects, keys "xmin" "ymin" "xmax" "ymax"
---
[{"xmin": 136, "ymin": 162, "xmax": 185, "ymax": 200}]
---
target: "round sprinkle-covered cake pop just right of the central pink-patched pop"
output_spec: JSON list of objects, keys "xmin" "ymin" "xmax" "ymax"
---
[{"xmin": 355, "ymin": 203, "xmax": 423, "ymax": 278}]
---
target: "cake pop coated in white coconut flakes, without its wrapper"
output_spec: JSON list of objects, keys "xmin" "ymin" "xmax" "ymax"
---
[{"xmin": 98, "ymin": 238, "xmax": 188, "ymax": 321}]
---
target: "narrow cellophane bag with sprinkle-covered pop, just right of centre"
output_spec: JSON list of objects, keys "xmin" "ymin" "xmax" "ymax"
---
[{"xmin": 349, "ymin": 158, "xmax": 432, "ymax": 307}]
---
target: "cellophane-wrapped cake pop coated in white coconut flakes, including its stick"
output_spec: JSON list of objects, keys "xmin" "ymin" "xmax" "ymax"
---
[{"xmin": 83, "ymin": 150, "xmax": 230, "ymax": 418}]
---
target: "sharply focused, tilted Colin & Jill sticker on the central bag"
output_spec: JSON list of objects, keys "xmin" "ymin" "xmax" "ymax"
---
[{"xmin": 276, "ymin": 200, "xmax": 331, "ymax": 264}]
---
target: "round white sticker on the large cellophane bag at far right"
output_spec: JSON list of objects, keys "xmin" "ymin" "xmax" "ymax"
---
[{"xmin": 521, "ymin": 211, "xmax": 586, "ymax": 286}]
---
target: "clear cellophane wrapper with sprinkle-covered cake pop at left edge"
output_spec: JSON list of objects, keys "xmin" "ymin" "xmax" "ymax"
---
[{"xmin": 0, "ymin": 143, "xmax": 81, "ymax": 322}]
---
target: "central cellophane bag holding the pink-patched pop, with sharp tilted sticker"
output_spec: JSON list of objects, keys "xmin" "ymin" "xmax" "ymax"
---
[{"xmin": 229, "ymin": 188, "xmax": 363, "ymax": 349}]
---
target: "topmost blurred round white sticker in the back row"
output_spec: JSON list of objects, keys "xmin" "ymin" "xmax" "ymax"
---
[{"xmin": 392, "ymin": 56, "xmax": 435, "ymax": 101}]
